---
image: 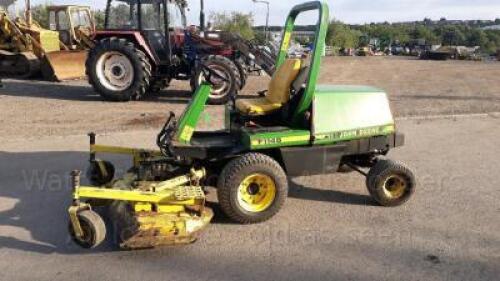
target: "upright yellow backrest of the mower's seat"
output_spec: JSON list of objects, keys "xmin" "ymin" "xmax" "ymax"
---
[{"xmin": 266, "ymin": 59, "xmax": 302, "ymax": 104}]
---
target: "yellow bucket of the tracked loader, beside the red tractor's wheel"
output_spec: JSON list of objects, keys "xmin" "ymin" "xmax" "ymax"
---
[{"xmin": 41, "ymin": 51, "xmax": 88, "ymax": 81}]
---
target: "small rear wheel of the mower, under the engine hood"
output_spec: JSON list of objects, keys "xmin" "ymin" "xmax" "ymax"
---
[{"xmin": 366, "ymin": 159, "xmax": 416, "ymax": 207}]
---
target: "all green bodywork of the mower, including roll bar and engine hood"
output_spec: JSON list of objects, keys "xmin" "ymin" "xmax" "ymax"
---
[{"xmin": 176, "ymin": 1, "xmax": 395, "ymax": 150}]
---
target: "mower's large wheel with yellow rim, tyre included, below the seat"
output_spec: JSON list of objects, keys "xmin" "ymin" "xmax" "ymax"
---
[{"xmin": 217, "ymin": 153, "xmax": 288, "ymax": 224}]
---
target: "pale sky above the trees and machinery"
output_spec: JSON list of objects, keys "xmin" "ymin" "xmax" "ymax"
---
[{"xmin": 30, "ymin": 0, "xmax": 500, "ymax": 25}]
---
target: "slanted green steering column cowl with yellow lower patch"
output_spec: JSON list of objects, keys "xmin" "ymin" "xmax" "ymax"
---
[{"xmin": 175, "ymin": 82, "xmax": 212, "ymax": 144}]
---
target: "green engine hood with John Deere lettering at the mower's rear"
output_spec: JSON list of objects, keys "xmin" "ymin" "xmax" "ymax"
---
[{"xmin": 312, "ymin": 86, "xmax": 395, "ymax": 144}]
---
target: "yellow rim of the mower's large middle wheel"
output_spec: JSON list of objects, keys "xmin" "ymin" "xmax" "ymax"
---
[{"xmin": 238, "ymin": 174, "xmax": 276, "ymax": 213}]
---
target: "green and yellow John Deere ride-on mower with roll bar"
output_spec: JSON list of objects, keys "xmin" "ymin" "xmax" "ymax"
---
[{"xmin": 69, "ymin": 1, "xmax": 415, "ymax": 249}]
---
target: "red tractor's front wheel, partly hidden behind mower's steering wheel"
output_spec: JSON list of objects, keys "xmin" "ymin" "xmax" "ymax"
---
[{"xmin": 191, "ymin": 55, "xmax": 242, "ymax": 104}]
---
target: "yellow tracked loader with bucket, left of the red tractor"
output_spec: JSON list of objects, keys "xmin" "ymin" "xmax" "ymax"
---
[{"xmin": 0, "ymin": 0, "xmax": 95, "ymax": 81}]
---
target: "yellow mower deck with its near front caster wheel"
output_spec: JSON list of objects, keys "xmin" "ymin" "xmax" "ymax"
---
[{"xmin": 69, "ymin": 164, "xmax": 213, "ymax": 249}]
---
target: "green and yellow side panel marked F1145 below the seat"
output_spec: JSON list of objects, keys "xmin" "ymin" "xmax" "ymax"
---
[{"xmin": 242, "ymin": 129, "xmax": 311, "ymax": 150}]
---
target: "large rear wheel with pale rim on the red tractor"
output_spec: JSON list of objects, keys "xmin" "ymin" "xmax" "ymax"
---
[{"xmin": 85, "ymin": 37, "xmax": 152, "ymax": 101}]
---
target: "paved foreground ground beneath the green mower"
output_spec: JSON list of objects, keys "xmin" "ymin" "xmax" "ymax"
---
[{"xmin": 0, "ymin": 117, "xmax": 500, "ymax": 281}]
